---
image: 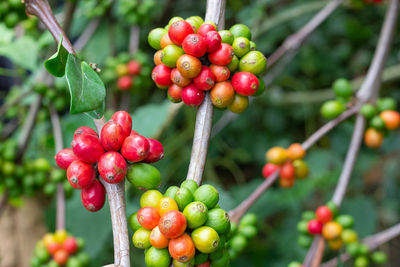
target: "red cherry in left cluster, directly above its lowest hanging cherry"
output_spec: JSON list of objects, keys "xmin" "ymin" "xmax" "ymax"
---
[{"xmin": 67, "ymin": 160, "xmax": 96, "ymax": 189}]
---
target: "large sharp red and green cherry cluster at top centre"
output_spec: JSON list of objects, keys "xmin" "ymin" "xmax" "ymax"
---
[{"xmin": 148, "ymin": 16, "xmax": 267, "ymax": 113}]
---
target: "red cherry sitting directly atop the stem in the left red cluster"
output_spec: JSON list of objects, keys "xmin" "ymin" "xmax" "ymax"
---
[{"xmin": 97, "ymin": 151, "xmax": 128, "ymax": 184}]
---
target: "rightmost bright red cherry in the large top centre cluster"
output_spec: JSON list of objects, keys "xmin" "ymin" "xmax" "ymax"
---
[{"xmin": 232, "ymin": 71, "xmax": 259, "ymax": 96}]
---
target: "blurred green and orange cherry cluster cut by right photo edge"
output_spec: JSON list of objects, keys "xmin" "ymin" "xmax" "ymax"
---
[{"xmin": 360, "ymin": 98, "xmax": 400, "ymax": 148}]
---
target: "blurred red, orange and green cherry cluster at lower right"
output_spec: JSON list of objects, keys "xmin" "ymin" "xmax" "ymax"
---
[{"xmin": 289, "ymin": 202, "xmax": 387, "ymax": 267}]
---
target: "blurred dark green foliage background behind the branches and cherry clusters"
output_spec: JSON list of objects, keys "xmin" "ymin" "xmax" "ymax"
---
[{"xmin": 0, "ymin": 0, "xmax": 400, "ymax": 267}]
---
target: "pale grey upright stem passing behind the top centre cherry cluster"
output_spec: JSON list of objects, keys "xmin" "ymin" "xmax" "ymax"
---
[{"xmin": 186, "ymin": 0, "xmax": 226, "ymax": 185}]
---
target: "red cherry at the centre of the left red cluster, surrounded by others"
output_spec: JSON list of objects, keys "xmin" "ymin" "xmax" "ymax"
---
[{"xmin": 100, "ymin": 120, "xmax": 125, "ymax": 151}]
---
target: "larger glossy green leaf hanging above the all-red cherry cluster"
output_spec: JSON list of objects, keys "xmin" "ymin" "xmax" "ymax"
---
[{"xmin": 65, "ymin": 54, "xmax": 106, "ymax": 116}]
